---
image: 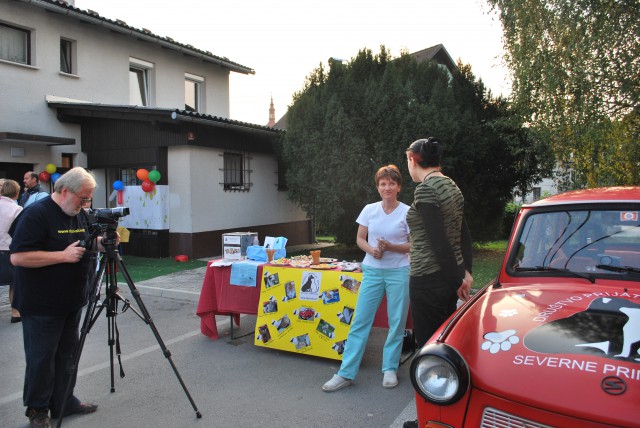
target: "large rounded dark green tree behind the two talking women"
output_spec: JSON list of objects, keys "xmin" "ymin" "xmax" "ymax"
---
[{"xmin": 281, "ymin": 47, "xmax": 545, "ymax": 243}]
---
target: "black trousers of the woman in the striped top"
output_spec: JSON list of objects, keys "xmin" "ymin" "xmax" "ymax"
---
[{"xmin": 409, "ymin": 271, "xmax": 462, "ymax": 349}]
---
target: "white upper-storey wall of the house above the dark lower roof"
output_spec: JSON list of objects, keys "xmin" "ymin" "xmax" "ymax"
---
[{"xmin": 0, "ymin": 0, "xmax": 229, "ymax": 171}]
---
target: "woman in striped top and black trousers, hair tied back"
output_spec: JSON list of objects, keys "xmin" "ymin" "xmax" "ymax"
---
[{"xmin": 403, "ymin": 137, "xmax": 473, "ymax": 428}]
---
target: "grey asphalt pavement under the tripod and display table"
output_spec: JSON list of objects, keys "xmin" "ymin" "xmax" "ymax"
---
[{"xmin": 0, "ymin": 246, "xmax": 415, "ymax": 428}]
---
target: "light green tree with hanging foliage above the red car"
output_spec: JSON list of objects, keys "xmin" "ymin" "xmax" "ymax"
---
[{"xmin": 487, "ymin": 0, "xmax": 640, "ymax": 188}]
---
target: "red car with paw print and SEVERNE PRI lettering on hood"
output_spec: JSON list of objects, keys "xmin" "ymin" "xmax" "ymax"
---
[{"xmin": 411, "ymin": 187, "xmax": 640, "ymax": 428}]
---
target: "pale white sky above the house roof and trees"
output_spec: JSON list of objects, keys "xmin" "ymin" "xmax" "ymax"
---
[{"xmin": 75, "ymin": 0, "xmax": 510, "ymax": 125}]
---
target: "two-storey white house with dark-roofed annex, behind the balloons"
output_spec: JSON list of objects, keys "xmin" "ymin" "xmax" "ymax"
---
[{"xmin": 0, "ymin": 0, "xmax": 312, "ymax": 258}]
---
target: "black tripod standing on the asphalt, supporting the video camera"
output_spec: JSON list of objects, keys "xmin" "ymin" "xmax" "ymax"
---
[{"xmin": 57, "ymin": 229, "xmax": 202, "ymax": 428}]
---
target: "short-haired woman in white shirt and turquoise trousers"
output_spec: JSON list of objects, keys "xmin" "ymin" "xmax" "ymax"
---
[{"xmin": 322, "ymin": 165, "xmax": 409, "ymax": 392}]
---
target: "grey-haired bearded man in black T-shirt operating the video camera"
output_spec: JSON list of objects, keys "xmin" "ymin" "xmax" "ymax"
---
[{"xmin": 10, "ymin": 167, "xmax": 117, "ymax": 427}]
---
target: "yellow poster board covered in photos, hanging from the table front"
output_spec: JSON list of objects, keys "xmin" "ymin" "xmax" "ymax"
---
[{"xmin": 254, "ymin": 265, "xmax": 362, "ymax": 360}]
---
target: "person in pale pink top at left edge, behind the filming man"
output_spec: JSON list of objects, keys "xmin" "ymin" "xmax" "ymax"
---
[{"xmin": 0, "ymin": 179, "xmax": 22, "ymax": 323}]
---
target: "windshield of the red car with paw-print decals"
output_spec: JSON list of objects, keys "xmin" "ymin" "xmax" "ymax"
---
[{"xmin": 510, "ymin": 209, "xmax": 640, "ymax": 280}]
